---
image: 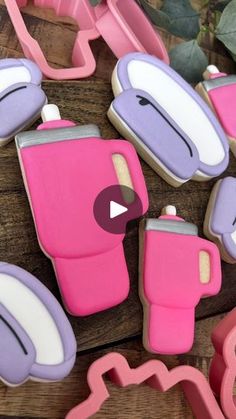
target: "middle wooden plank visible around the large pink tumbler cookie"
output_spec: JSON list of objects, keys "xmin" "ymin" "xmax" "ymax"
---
[{"xmin": 0, "ymin": 81, "xmax": 236, "ymax": 351}]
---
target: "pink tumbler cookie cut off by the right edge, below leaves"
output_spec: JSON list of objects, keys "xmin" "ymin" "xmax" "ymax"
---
[{"xmin": 196, "ymin": 65, "xmax": 236, "ymax": 156}]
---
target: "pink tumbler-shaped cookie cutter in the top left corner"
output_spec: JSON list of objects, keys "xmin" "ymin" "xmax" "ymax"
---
[{"xmin": 5, "ymin": 0, "xmax": 100, "ymax": 80}]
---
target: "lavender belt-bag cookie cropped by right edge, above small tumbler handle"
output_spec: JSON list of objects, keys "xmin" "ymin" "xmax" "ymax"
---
[{"xmin": 204, "ymin": 177, "xmax": 236, "ymax": 263}]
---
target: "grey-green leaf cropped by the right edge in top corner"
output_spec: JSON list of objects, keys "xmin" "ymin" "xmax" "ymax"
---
[{"xmin": 215, "ymin": 0, "xmax": 236, "ymax": 55}]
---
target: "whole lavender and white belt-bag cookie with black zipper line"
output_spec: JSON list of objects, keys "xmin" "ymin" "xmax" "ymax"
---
[{"xmin": 108, "ymin": 53, "xmax": 229, "ymax": 187}]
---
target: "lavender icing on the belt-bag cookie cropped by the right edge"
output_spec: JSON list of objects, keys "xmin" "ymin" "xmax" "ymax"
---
[{"xmin": 209, "ymin": 177, "xmax": 236, "ymax": 259}]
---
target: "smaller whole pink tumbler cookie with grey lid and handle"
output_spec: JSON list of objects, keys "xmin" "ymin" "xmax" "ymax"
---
[{"xmin": 140, "ymin": 206, "xmax": 221, "ymax": 355}]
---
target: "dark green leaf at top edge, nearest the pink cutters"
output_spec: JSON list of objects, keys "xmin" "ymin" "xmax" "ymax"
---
[{"xmin": 140, "ymin": 0, "xmax": 200, "ymax": 39}]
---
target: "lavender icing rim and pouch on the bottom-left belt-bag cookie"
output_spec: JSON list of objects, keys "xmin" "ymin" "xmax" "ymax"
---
[{"xmin": 0, "ymin": 263, "xmax": 76, "ymax": 385}]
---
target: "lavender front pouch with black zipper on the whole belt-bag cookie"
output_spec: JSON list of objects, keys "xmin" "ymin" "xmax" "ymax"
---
[{"xmin": 113, "ymin": 89, "xmax": 199, "ymax": 179}]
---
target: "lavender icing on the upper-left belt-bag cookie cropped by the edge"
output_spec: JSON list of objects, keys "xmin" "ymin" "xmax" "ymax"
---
[{"xmin": 0, "ymin": 58, "xmax": 47, "ymax": 139}]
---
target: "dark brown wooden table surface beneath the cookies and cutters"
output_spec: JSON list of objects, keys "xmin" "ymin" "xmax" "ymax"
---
[{"xmin": 0, "ymin": 0, "xmax": 236, "ymax": 419}]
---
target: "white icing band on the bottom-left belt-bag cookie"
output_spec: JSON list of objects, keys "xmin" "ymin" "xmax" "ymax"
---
[{"xmin": 0, "ymin": 273, "xmax": 64, "ymax": 365}]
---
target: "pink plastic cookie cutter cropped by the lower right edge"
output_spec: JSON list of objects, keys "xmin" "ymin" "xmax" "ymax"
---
[{"xmin": 209, "ymin": 308, "xmax": 236, "ymax": 419}]
